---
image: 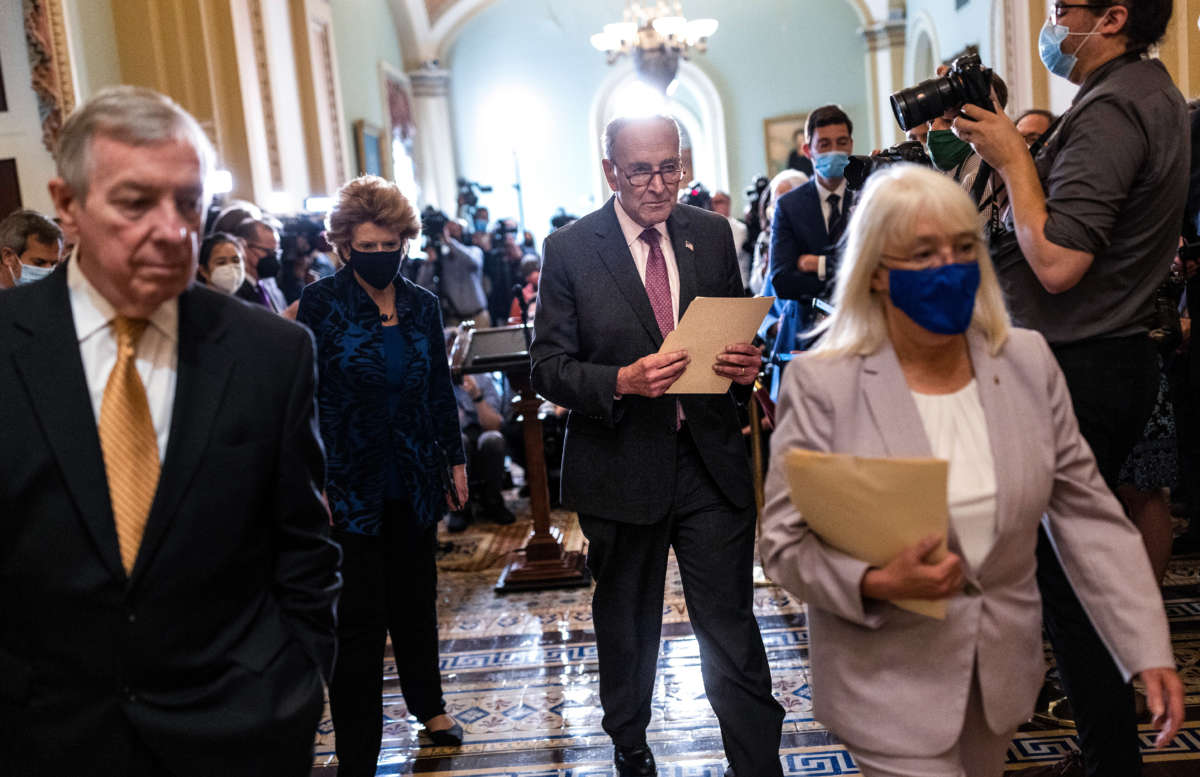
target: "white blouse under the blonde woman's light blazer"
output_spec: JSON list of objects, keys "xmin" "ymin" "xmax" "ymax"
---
[{"xmin": 912, "ymin": 379, "xmax": 996, "ymax": 570}]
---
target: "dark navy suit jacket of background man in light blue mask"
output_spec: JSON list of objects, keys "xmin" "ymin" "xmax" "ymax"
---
[{"xmin": 770, "ymin": 177, "xmax": 850, "ymax": 329}]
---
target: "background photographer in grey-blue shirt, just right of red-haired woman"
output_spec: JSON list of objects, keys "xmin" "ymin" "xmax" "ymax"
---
[{"xmin": 416, "ymin": 206, "xmax": 492, "ymax": 329}]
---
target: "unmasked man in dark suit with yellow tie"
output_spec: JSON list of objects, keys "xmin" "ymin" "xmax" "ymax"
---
[{"xmin": 0, "ymin": 86, "xmax": 341, "ymax": 777}]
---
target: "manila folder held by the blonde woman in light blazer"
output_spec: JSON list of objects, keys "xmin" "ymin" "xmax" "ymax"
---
[{"xmin": 786, "ymin": 448, "xmax": 949, "ymax": 619}]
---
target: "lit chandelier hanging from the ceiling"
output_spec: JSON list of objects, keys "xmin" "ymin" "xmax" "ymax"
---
[{"xmin": 592, "ymin": 0, "xmax": 716, "ymax": 92}]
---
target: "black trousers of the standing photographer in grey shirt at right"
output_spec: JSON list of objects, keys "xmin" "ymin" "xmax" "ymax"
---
[{"xmin": 1038, "ymin": 335, "xmax": 1158, "ymax": 777}]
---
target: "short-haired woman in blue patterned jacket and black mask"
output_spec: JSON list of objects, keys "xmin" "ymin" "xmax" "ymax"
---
[{"xmin": 296, "ymin": 175, "xmax": 467, "ymax": 777}]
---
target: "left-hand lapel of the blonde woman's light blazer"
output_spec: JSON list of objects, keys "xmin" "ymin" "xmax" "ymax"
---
[{"xmin": 863, "ymin": 342, "xmax": 962, "ymax": 556}]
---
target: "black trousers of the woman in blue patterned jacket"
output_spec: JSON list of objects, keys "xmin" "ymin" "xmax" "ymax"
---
[{"xmin": 329, "ymin": 502, "xmax": 445, "ymax": 777}]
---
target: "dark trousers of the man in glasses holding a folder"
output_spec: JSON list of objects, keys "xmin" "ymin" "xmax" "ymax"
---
[{"xmin": 580, "ymin": 427, "xmax": 784, "ymax": 777}]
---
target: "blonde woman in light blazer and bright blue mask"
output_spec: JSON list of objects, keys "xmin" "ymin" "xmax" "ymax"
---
[{"xmin": 761, "ymin": 165, "xmax": 1183, "ymax": 777}]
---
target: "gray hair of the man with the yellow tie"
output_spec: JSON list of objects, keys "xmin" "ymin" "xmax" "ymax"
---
[{"xmin": 54, "ymin": 86, "xmax": 216, "ymax": 199}]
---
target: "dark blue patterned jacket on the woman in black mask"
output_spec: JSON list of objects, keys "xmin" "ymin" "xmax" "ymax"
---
[{"xmin": 296, "ymin": 267, "xmax": 466, "ymax": 535}]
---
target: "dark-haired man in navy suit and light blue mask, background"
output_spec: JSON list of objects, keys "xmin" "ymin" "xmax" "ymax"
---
[{"xmin": 769, "ymin": 106, "xmax": 854, "ymax": 340}]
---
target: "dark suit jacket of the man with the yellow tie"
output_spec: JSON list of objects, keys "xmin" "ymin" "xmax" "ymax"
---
[{"xmin": 0, "ymin": 267, "xmax": 341, "ymax": 776}]
